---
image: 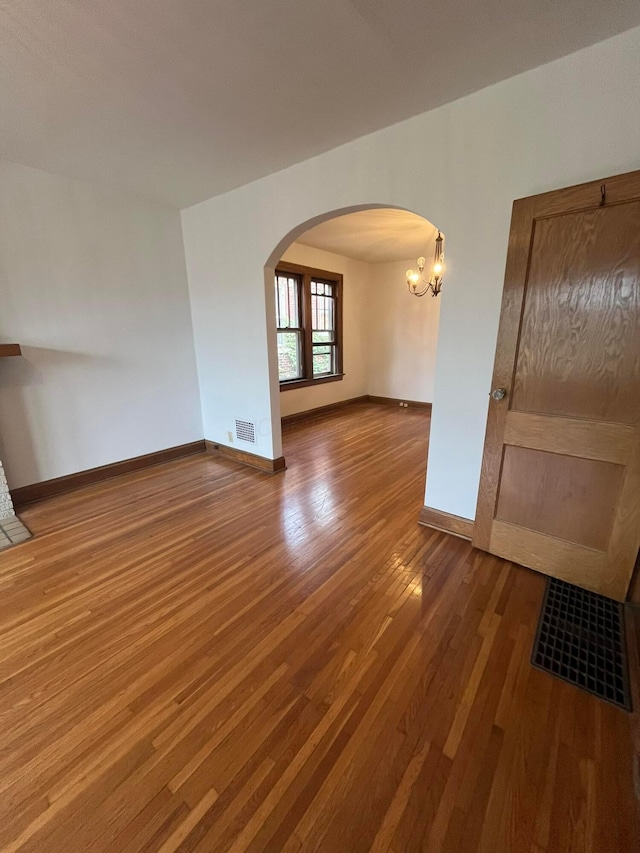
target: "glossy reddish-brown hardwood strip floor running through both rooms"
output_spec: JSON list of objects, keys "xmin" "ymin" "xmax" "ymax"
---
[{"xmin": 0, "ymin": 405, "xmax": 640, "ymax": 853}]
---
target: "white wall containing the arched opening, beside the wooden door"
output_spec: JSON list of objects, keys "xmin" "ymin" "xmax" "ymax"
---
[{"xmin": 183, "ymin": 29, "xmax": 640, "ymax": 518}]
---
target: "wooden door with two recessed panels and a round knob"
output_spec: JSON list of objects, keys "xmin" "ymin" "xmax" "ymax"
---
[{"xmin": 473, "ymin": 172, "xmax": 640, "ymax": 601}]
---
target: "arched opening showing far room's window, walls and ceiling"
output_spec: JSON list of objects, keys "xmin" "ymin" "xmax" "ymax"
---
[{"xmin": 265, "ymin": 205, "xmax": 442, "ymax": 482}]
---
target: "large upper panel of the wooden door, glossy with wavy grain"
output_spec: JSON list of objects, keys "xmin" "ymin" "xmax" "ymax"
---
[{"xmin": 511, "ymin": 206, "xmax": 640, "ymax": 424}]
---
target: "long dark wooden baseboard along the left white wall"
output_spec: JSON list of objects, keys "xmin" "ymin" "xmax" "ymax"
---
[{"xmin": 11, "ymin": 439, "xmax": 205, "ymax": 507}]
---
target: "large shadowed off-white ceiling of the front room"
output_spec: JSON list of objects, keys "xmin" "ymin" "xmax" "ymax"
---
[{"xmin": 0, "ymin": 0, "xmax": 640, "ymax": 207}]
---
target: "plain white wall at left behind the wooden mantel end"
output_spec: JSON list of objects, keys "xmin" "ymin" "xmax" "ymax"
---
[{"xmin": 0, "ymin": 162, "xmax": 202, "ymax": 487}]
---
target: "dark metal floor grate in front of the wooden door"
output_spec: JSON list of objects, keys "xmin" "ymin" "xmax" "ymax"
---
[{"xmin": 531, "ymin": 578, "xmax": 631, "ymax": 711}]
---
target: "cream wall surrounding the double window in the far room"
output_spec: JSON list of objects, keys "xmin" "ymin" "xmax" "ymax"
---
[{"xmin": 280, "ymin": 243, "xmax": 371, "ymax": 415}]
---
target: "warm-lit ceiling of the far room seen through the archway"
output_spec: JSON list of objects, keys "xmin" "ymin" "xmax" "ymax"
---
[{"xmin": 297, "ymin": 208, "xmax": 437, "ymax": 266}]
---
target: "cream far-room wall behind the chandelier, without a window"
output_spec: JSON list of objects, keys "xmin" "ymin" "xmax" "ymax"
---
[{"xmin": 367, "ymin": 258, "xmax": 441, "ymax": 403}]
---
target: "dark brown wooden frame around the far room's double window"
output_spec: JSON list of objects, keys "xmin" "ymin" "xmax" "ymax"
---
[{"xmin": 274, "ymin": 261, "xmax": 344, "ymax": 391}]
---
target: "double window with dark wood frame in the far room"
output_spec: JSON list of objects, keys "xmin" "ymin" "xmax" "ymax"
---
[{"xmin": 275, "ymin": 262, "xmax": 342, "ymax": 390}]
